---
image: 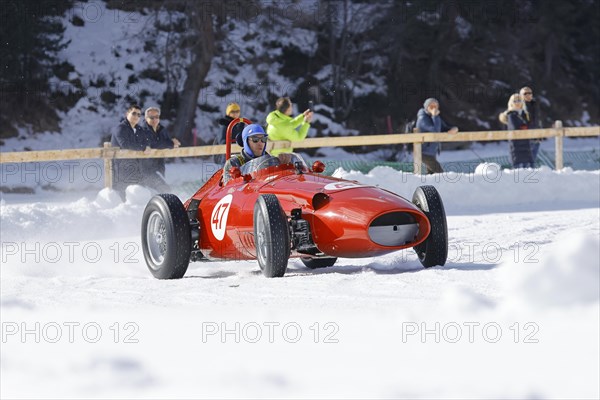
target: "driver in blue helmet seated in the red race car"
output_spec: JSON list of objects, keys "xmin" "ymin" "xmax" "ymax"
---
[{"xmin": 223, "ymin": 124, "xmax": 291, "ymax": 183}]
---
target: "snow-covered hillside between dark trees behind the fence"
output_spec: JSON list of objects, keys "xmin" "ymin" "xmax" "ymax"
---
[{"xmin": 2, "ymin": 1, "xmax": 340, "ymax": 151}]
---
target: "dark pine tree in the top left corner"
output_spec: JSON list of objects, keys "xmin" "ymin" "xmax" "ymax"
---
[{"xmin": 0, "ymin": 0, "xmax": 71, "ymax": 137}]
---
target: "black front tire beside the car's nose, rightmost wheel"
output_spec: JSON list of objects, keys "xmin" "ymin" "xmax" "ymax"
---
[{"xmin": 412, "ymin": 185, "xmax": 448, "ymax": 268}]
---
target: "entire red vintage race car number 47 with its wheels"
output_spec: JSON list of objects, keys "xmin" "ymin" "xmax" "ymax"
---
[{"xmin": 142, "ymin": 118, "xmax": 448, "ymax": 279}]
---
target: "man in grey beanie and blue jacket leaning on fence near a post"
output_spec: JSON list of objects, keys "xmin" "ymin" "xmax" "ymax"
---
[{"xmin": 417, "ymin": 98, "xmax": 458, "ymax": 174}]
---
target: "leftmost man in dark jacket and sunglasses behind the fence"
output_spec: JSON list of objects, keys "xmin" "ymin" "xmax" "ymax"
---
[{"xmin": 110, "ymin": 104, "xmax": 148, "ymax": 199}]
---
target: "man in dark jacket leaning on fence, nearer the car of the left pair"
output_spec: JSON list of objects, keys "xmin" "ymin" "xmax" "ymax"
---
[{"xmin": 140, "ymin": 107, "xmax": 181, "ymax": 193}]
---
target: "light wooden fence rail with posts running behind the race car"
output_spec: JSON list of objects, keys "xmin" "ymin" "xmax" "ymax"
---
[{"xmin": 0, "ymin": 121, "xmax": 600, "ymax": 187}]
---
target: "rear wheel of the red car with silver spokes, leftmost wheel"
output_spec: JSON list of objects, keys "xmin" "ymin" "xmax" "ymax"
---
[{"xmin": 142, "ymin": 194, "xmax": 192, "ymax": 279}]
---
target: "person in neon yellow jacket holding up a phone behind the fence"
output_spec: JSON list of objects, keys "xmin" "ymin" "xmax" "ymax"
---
[{"xmin": 267, "ymin": 97, "xmax": 313, "ymax": 156}]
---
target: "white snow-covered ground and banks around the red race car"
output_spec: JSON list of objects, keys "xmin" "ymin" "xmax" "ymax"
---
[{"xmin": 0, "ymin": 163, "xmax": 600, "ymax": 399}]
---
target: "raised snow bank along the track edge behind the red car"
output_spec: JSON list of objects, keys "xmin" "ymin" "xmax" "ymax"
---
[{"xmin": 0, "ymin": 163, "xmax": 600, "ymax": 244}]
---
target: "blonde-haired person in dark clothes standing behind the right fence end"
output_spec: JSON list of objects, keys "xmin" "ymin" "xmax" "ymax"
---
[{"xmin": 499, "ymin": 93, "xmax": 533, "ymax": 168}]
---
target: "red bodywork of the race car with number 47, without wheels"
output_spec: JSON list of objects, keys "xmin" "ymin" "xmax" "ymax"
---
[{"xmin": 185, "ymin": 164, "xmax": 431, "ymax": 260}]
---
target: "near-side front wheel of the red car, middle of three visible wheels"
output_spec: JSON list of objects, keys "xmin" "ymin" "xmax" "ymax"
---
[{"xmin": 254, "ymin": 194, "xmax": 291, "ymax": 278}]
